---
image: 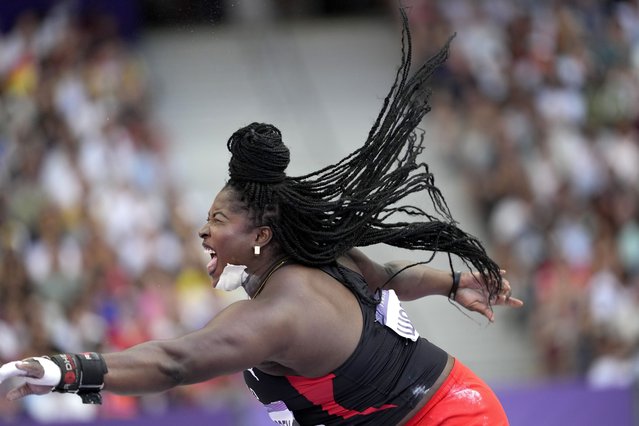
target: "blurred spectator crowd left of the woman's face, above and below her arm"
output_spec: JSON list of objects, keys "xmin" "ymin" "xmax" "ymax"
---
[{"xmin": 0, "ymin": 3, "xmax": 245, "ymax": 423}]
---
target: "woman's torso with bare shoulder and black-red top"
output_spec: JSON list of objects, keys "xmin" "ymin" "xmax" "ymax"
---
[{"xmin": 244, "ymin": 265, "xmax": 448, "ymax": 424}]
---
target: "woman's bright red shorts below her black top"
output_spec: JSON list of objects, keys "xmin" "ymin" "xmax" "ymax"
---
[{"xmin": 406, "ymin": 359, "xmax": 509, "ymax": 426}]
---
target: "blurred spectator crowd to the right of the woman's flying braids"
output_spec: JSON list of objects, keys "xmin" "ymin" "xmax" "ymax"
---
[{"xmin": 409, "ymin": 0, "xmax": 639, "ymax": 387}]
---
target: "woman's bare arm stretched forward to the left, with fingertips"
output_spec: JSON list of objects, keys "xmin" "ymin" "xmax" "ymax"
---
[{"xmin": 0, "ymin": 299, "xmax": 295, "ymax": 399}]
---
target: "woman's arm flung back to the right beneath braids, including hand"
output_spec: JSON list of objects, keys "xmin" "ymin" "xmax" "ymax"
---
[{"xmin": 347, "ymin": 249, "xmax": 523, "ymax": 321}]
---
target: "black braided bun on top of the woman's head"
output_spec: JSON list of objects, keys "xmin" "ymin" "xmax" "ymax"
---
[{"xmin": 227, "ymin": 123, "xmax": 290, "ymax": 184}]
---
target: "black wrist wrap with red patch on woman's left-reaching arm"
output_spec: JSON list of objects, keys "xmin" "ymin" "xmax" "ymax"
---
[{"xmin": 49, "ymin": 352, "xmax": 108, "ymax": 404}]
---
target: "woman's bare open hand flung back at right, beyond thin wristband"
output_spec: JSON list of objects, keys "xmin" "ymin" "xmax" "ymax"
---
[{"xmin": 455, "ymin": 270, "xmax": 524, "ymax": 322}]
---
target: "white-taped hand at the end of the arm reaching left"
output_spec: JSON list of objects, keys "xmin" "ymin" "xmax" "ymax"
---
[{"xmin": 0, "ymin": 358, "xmax": 61, "ymax": 401}]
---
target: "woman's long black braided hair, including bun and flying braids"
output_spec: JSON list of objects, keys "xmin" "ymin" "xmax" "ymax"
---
[{"xmin": 227, "ymin": 10, "xmax": 501, "ymax": 300}]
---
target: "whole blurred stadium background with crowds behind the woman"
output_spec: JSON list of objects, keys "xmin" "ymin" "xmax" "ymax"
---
[{"xmin": 0, "ymin": 0, "xmax": 639, "ymax": 426}]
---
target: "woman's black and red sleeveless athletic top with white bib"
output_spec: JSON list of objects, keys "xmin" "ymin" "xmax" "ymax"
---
[{"xmin": 244, "ymin": 264, "xmax": 448, "ymax": 426}]
